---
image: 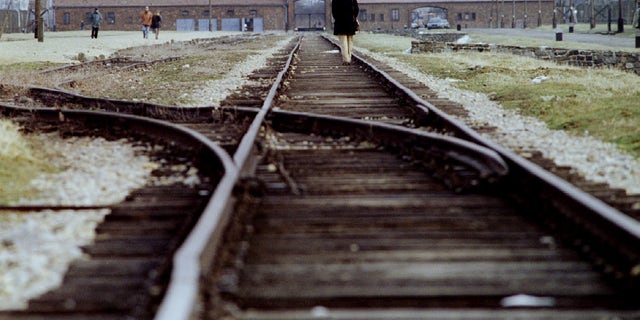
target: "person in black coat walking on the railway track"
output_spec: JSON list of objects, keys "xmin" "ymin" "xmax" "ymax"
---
[{"xmin": 331, "ymin": 0, "xmax": 360, "ymax": 65}]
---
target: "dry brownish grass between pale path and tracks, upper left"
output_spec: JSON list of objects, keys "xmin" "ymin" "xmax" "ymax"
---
[{"xmin": 0, "ymin": 34, "xmax": 287, "ymax": 105}]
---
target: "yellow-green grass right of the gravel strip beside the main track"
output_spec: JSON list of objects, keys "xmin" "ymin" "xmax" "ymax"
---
[{"xmin": 355, "ymin": 34, "xmax": 640, "ymax": 158}]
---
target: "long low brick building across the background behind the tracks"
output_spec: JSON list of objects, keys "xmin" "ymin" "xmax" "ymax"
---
[{"xmin": 49, "ymin": 0, "xmax": 554, "ymax": 32}]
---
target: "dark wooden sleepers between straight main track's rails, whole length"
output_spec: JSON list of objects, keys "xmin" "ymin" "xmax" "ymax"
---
[{"xmin": 205, "ymin": 33, "xmax": 638, "ymax": 319}]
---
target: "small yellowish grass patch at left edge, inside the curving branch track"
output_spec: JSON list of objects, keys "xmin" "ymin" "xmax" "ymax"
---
[{"xmin": 0, "ymin": 120, "xmax": 55, "ymax": 204}]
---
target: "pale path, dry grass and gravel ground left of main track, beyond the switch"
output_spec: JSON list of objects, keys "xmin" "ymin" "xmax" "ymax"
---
[{"xmin": 0, "ymin": 32, "xmax": 292, "ymax": 107}]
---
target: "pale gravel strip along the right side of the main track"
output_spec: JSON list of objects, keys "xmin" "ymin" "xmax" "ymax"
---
[{"xmin": 357, "ymin": 48, "xmax": 640, "ymax": 194}]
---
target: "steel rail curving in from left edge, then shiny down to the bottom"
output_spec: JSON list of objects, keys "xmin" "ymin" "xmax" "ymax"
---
[{"xmin": 0, "ymin": 104, "xmax": 239, "ymax": 320}]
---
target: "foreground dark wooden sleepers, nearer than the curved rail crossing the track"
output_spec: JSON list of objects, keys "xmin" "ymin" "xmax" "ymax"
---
[{"xmin": 211, "ymin": 112, "xmax": 637, "ymax": 319}]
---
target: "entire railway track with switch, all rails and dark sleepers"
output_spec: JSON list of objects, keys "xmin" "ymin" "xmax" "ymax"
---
[{"xmin": 0, "ymin": 34, "xmax": 640, "ymax": 320}]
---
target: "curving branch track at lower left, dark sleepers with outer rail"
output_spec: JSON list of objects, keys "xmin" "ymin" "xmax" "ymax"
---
[{"xmin": 0, "ymin": 107, "xmax": 233, "ymax": 319}]
